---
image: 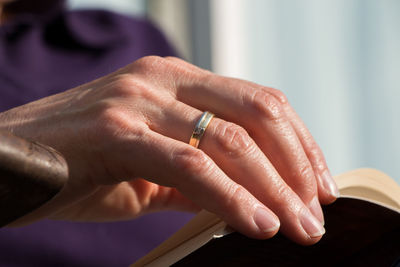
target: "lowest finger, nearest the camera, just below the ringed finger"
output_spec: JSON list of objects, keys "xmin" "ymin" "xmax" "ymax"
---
[{"xmin": 104, "ymin": 125, "xmax": 280, "ymax": 239}]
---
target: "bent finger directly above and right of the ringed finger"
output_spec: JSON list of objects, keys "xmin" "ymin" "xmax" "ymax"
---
[{"xmin": 176, "ymin": 74, "xmax": 324, "ymax": 223}]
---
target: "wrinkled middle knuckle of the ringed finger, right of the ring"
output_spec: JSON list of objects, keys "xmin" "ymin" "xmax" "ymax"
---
[{"xmin": 215, "ymin": 121, "xmax": 255, "ymax": 158}]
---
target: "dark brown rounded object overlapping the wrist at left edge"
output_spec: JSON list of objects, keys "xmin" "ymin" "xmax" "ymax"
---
[{"xmin": 0, "ymin": 131, "xmax": 68, "ymax": 227}]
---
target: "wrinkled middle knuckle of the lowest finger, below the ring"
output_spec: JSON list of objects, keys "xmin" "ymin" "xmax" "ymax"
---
[{"xmin": 172, "ymin": 147, "xmax": 212, "ymax": 177}]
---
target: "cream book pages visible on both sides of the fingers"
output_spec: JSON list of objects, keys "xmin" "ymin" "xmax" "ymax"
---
[{"xmin": 131, "ymin": 169, "xmax": 400, "ymax": 267}]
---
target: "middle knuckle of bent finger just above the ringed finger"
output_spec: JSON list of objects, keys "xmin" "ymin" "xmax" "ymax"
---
[{"xmin": 250, "ymin": 90, "xmax": 285, "ymax": 121}]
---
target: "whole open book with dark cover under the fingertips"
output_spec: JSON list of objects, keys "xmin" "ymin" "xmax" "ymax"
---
[{"xmin": 131, "ymin": 169, "xmax": 400, "ymax": 267}]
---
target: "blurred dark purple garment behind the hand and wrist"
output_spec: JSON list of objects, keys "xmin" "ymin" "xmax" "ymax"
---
[{"xmin": 0, "ymin": 1, "xmax": 192, "ymax": 266}]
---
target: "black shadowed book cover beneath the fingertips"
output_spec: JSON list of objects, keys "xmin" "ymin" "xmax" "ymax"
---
[{"xmin": 173, "ymin": 198, "xmax": 400, "ymax": 267}]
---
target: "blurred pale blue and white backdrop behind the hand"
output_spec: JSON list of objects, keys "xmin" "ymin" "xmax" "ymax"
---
[{"xmin": 69, "ymin": 0, "xmax": 400, "ymax": 183}]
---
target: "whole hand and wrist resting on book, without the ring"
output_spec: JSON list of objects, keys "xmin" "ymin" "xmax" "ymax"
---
[{"xmin": 0, "ymin": 57, "xmax": 338, "ymax": 244}]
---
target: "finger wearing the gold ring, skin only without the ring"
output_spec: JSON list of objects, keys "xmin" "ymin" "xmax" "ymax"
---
[{"xmin": 148, "ymin": 99, "xmax": 324, "ymax": 243}]
